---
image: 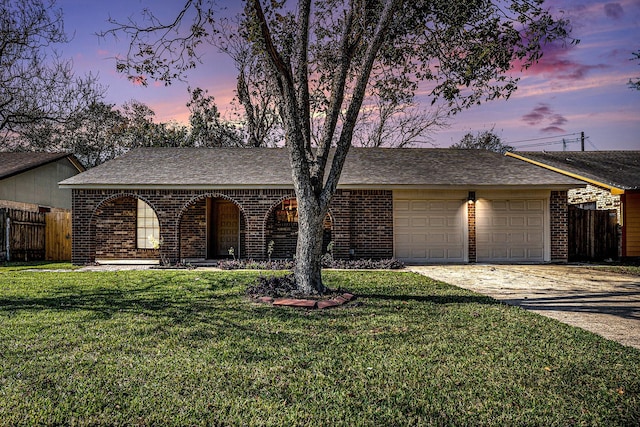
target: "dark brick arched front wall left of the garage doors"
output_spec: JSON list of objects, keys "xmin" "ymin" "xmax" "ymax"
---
[{"xmin": 72, "ymin": 189, "xmax": 393, "ymax": 264}]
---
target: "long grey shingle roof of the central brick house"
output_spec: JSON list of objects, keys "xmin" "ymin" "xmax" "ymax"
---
[{"xmin": 60, "ymin": 148, "xmax": 581, "ymax": 188}]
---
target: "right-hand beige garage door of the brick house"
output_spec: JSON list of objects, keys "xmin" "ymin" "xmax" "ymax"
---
[{"xmin": 476, "ymin": 199, "xmax": 546, "ymax": 262}]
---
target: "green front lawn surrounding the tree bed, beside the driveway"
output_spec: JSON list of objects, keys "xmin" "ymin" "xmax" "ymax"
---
[{"xmin": 0, "ymin": 268, "xmax": 640, "ymax": 426}]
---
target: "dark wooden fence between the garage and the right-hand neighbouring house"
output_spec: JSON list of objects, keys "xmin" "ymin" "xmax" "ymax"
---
[{"xmin": 569, "ymin": 205, "xmax": 618, "ymax": 261}]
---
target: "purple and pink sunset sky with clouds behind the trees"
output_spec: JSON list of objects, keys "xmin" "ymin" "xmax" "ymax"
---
[{"xmin": 58, "ymin": 0, "xmax": 640, "ymax": 151}]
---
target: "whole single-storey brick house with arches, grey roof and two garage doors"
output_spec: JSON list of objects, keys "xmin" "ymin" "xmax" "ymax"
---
[{"xmin": 60, "ymin": 148, "xmax": 582, "ymax": 264}]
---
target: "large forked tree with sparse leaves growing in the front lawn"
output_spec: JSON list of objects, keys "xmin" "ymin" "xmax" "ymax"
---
[{"xmin": 105, "ymin": 0, "xmax": 568, "ymax": 293}]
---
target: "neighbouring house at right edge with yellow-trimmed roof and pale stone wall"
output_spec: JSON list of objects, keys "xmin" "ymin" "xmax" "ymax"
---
[{"xmin": 507, "ymin": 151, "xmax": 640, "ymax": 258}]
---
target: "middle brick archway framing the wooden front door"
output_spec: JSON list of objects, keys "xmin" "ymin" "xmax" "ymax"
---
[{"xmin": 180, "ymin": 195, "xmax": 246, "ymax": 260}]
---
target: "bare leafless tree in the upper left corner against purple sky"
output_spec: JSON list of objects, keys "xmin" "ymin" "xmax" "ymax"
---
[{"xmin": 0, "ymin": 0, "xmax": 102, "ymax": 136}]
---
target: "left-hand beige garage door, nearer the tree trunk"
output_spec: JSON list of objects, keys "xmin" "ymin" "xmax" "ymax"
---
[{"xmin": 393, "ymin": 199, "xmax": 466, "ymax": 264}]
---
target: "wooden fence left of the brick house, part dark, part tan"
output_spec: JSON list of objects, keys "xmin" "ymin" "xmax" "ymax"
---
[{"xmin": 0, "ymin": 208, "xmax": 71, "ymax": 261}]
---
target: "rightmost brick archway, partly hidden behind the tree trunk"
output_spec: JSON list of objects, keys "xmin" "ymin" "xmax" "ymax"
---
[{"xmin": 265, "ymin": 198, "xmax": 333, "ymax": 259}]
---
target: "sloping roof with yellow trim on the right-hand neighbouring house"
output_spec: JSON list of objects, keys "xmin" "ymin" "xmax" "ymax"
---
[{"xmin": 507, "ymin": 151, "xmax": 640, "ymax": 194}]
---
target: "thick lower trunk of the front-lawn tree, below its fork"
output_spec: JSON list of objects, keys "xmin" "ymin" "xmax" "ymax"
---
[{"xmin": 294, "ymin": 197, "xmax": 326, "ymax": 295}]
